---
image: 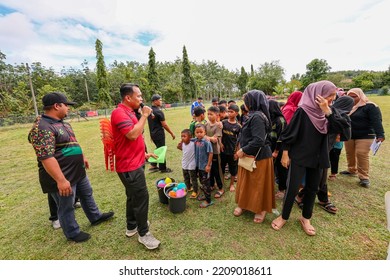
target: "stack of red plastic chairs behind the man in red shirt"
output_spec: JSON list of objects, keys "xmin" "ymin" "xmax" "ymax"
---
[{"xmin": 100, "ymin": 119, "xmax": 115, "ymax": 171}]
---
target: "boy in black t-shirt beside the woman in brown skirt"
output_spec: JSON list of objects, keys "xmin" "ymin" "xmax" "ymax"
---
[{"xmin": 221, "ymin": 104, "xmax": 241, "ymax": 192}]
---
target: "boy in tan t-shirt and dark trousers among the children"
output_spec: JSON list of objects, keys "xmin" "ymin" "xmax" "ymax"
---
[{"xmin": 206, "ymin": 106, "xmax": 225, "ymax": 198}]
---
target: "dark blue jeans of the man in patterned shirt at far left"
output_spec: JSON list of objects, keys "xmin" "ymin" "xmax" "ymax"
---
[{"xmin": 50, "ymin": 176, "xmax": 102, "ymax": 238}]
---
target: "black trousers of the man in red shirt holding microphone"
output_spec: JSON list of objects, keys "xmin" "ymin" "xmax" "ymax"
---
[{"xmin": 118, "ymin": 167, "xmax": 149, "ymax": 236}]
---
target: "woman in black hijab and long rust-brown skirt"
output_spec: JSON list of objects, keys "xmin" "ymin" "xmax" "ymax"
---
[{"xmin": 234, "ymin": 90, "xmax": 275, "ymax": 223}]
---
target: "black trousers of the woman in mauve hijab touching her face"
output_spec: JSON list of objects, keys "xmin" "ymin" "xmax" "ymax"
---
[{"xmin": 282, "ymin": 160, "xmax": 322, "ymax": 220}]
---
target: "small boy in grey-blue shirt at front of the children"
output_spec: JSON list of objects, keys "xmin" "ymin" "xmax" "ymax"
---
[{"xmin": 191, "ymin": 124, "xmax": 213, "ymax": 208}]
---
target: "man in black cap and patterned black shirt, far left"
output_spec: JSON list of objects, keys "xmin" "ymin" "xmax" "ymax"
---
[{"xmin": 28, "ymin": 92, "xmax": 114, "ymax": 242}]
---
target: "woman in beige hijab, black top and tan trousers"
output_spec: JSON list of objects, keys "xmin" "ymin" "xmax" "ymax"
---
[{"xmin": 340, "ymin": 88, "xmax": 385, "ymax": 188}]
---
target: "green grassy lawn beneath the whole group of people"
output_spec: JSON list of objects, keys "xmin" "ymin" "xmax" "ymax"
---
[{"xmin": 0, "ymin": 96, "xmax": 390, "ymax": 260}]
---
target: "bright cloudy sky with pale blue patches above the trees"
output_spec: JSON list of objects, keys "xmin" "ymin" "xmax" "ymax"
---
[{"xmin": 0, "ymin": 0, "xmax": 390, "ymax": 79}]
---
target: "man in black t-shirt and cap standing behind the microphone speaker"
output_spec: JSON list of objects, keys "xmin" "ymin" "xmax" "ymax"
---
[{"xmin": 148, "ymin": 94, "xmax": 175, "ymax": 173}]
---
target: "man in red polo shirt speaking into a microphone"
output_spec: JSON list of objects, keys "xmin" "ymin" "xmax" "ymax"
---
[{"xmin": 111, "ymin": 83, "xmax": 160, "ymax": 250}]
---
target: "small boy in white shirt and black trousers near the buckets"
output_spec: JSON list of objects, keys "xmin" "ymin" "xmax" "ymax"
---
[{"xmin": 177, "ymin": 129, "xmax": 198, "ymax": 198}]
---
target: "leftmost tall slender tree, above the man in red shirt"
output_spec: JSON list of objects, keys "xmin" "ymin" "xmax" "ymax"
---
[{"xmin": 95, "ymin": 39, "xmax": 111, "ymax": 106}]
